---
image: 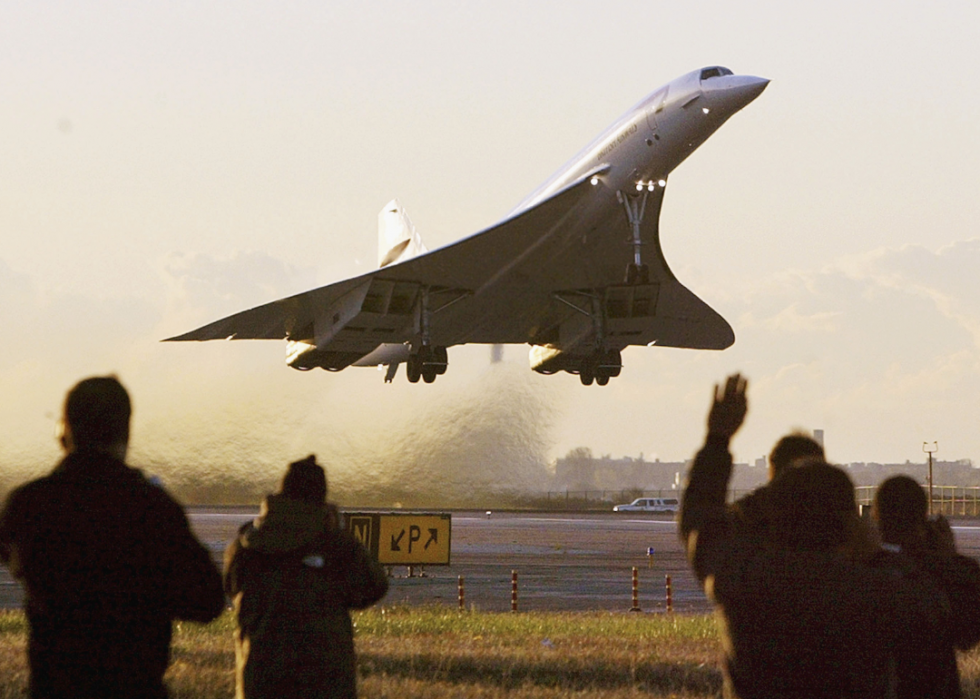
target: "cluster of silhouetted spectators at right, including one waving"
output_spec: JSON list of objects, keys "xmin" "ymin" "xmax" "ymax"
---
[{"xmin": 679, "ymin": 374, "xmax": 980, "ymax": 699}]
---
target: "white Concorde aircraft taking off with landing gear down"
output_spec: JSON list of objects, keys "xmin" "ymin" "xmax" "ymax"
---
[{"xmin": 166, "ymin": 66, "xmax": 769, "ymax": 386}]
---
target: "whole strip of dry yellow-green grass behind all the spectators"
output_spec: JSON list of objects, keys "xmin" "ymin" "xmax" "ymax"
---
[{"xmin": 0, "ymin": 607, "xmax": 980, "ymax": 699}]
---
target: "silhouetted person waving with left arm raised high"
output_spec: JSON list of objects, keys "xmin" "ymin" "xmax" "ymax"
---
[{"xmin": 680, "ymin": 374, "xmax": 904, "ymax": 698}]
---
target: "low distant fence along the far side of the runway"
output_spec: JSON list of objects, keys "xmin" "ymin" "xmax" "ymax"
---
[{"xmin": 540, "ymin": 485, "xmax": 980, "ymax": 517}]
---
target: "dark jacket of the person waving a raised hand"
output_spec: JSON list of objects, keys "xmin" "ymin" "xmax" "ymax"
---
[{"xmin": 680, "ymin": 439, "xmax": 902, "ymax": 699}]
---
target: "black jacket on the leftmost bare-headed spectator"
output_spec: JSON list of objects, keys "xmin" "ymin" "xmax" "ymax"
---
[{"xmin": 0, "ymin": 451, "xmax": 224, "ymax": 698}]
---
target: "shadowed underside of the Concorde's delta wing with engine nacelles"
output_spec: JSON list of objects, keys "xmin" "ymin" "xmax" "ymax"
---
[{"xmin": 166, "ymin": 167, "xmax": 734, "ymax": 378}]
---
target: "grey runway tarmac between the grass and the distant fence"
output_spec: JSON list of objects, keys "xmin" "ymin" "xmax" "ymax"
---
[{"xmin": 0, "ymin": 508, "xmax": 980, "ymax": 612}]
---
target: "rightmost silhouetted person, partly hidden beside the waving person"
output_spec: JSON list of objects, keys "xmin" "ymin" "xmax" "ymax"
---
[{"xmin": 872, "ymin": 476, "xmax": 980, "ymax": 699}]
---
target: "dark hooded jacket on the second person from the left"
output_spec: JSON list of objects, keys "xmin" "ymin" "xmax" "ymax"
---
[{"xmin": 225, "ymin": 495, "xmax": 388, "ymax": 699}]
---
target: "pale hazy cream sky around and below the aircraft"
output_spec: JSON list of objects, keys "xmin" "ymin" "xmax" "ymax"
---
[{"xmin": 0, "ymin": 0, "xmax": 980, "ymax": 504}]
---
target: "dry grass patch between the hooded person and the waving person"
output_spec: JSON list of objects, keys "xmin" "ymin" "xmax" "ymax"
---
[{"xmin": 358, "ymin": 608, "xmax": 720, "ymax": 699}]
